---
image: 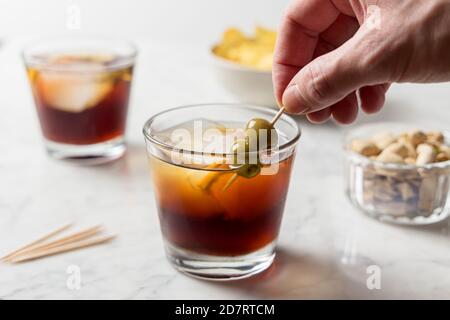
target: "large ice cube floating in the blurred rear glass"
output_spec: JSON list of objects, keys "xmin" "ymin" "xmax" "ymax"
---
[{"xmin": 36, "ymin": 71, "xmax": 113, "ymax": 113}]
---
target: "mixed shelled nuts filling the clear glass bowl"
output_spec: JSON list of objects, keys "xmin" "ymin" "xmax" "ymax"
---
[{"xmin": 349, "ymin": 130, "xmax": 450, "ymax": 218}]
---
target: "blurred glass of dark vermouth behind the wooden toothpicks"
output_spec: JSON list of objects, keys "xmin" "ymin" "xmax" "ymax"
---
[{"xmin": 23, "ymin": 37, "xmax": 137, "ymax": 164}]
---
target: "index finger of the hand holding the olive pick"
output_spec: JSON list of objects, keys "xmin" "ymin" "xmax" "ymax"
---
[{"xmin": 273, "ymin": 0, "xmax": 351, "ymax": 102}]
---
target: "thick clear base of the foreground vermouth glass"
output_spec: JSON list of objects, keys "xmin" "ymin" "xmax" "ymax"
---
[{"xmin": 166, "ymin": 242, "xmax": 275, "ymax": 281}]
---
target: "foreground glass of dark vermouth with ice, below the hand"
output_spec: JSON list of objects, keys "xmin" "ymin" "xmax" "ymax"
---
[{"xmin": 143, "ymin": 104, "xmax": 301, "ymax": 280}]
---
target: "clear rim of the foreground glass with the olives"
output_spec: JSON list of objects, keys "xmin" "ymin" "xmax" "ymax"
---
[{"xmin": 142, "ymin": 102, "xmax": 302, "ymax": 157}]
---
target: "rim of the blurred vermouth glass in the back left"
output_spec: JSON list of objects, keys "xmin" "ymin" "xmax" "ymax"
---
[{"xmin": 21, "ymin": 35, "xmax": 138, "ymax": 73}]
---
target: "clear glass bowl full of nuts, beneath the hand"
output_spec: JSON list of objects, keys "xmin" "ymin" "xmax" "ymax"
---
[{"xmin": 345, "ymin": 122, "xmax": 450, "ymax": 225}]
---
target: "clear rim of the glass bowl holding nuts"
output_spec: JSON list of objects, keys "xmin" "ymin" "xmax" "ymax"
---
[{"xmin": 343, "ymin": 121, "xmax": 450, "ymax": 170}]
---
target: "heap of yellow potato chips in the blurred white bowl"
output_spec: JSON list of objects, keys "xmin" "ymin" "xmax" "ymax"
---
[{"xmin": 213, "ymin": 26, "xmax": 277, "ymax": 71}]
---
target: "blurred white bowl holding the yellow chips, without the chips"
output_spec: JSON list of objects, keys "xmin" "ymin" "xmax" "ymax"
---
[{"xmin": 210, "ymin": 50, "xmax": 278, "ymax": 108}]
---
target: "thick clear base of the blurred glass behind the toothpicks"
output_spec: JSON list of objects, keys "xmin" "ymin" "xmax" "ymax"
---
[{"xmin": 45, "ymin": 137, "xmax": 126, "ymax": 165}]
